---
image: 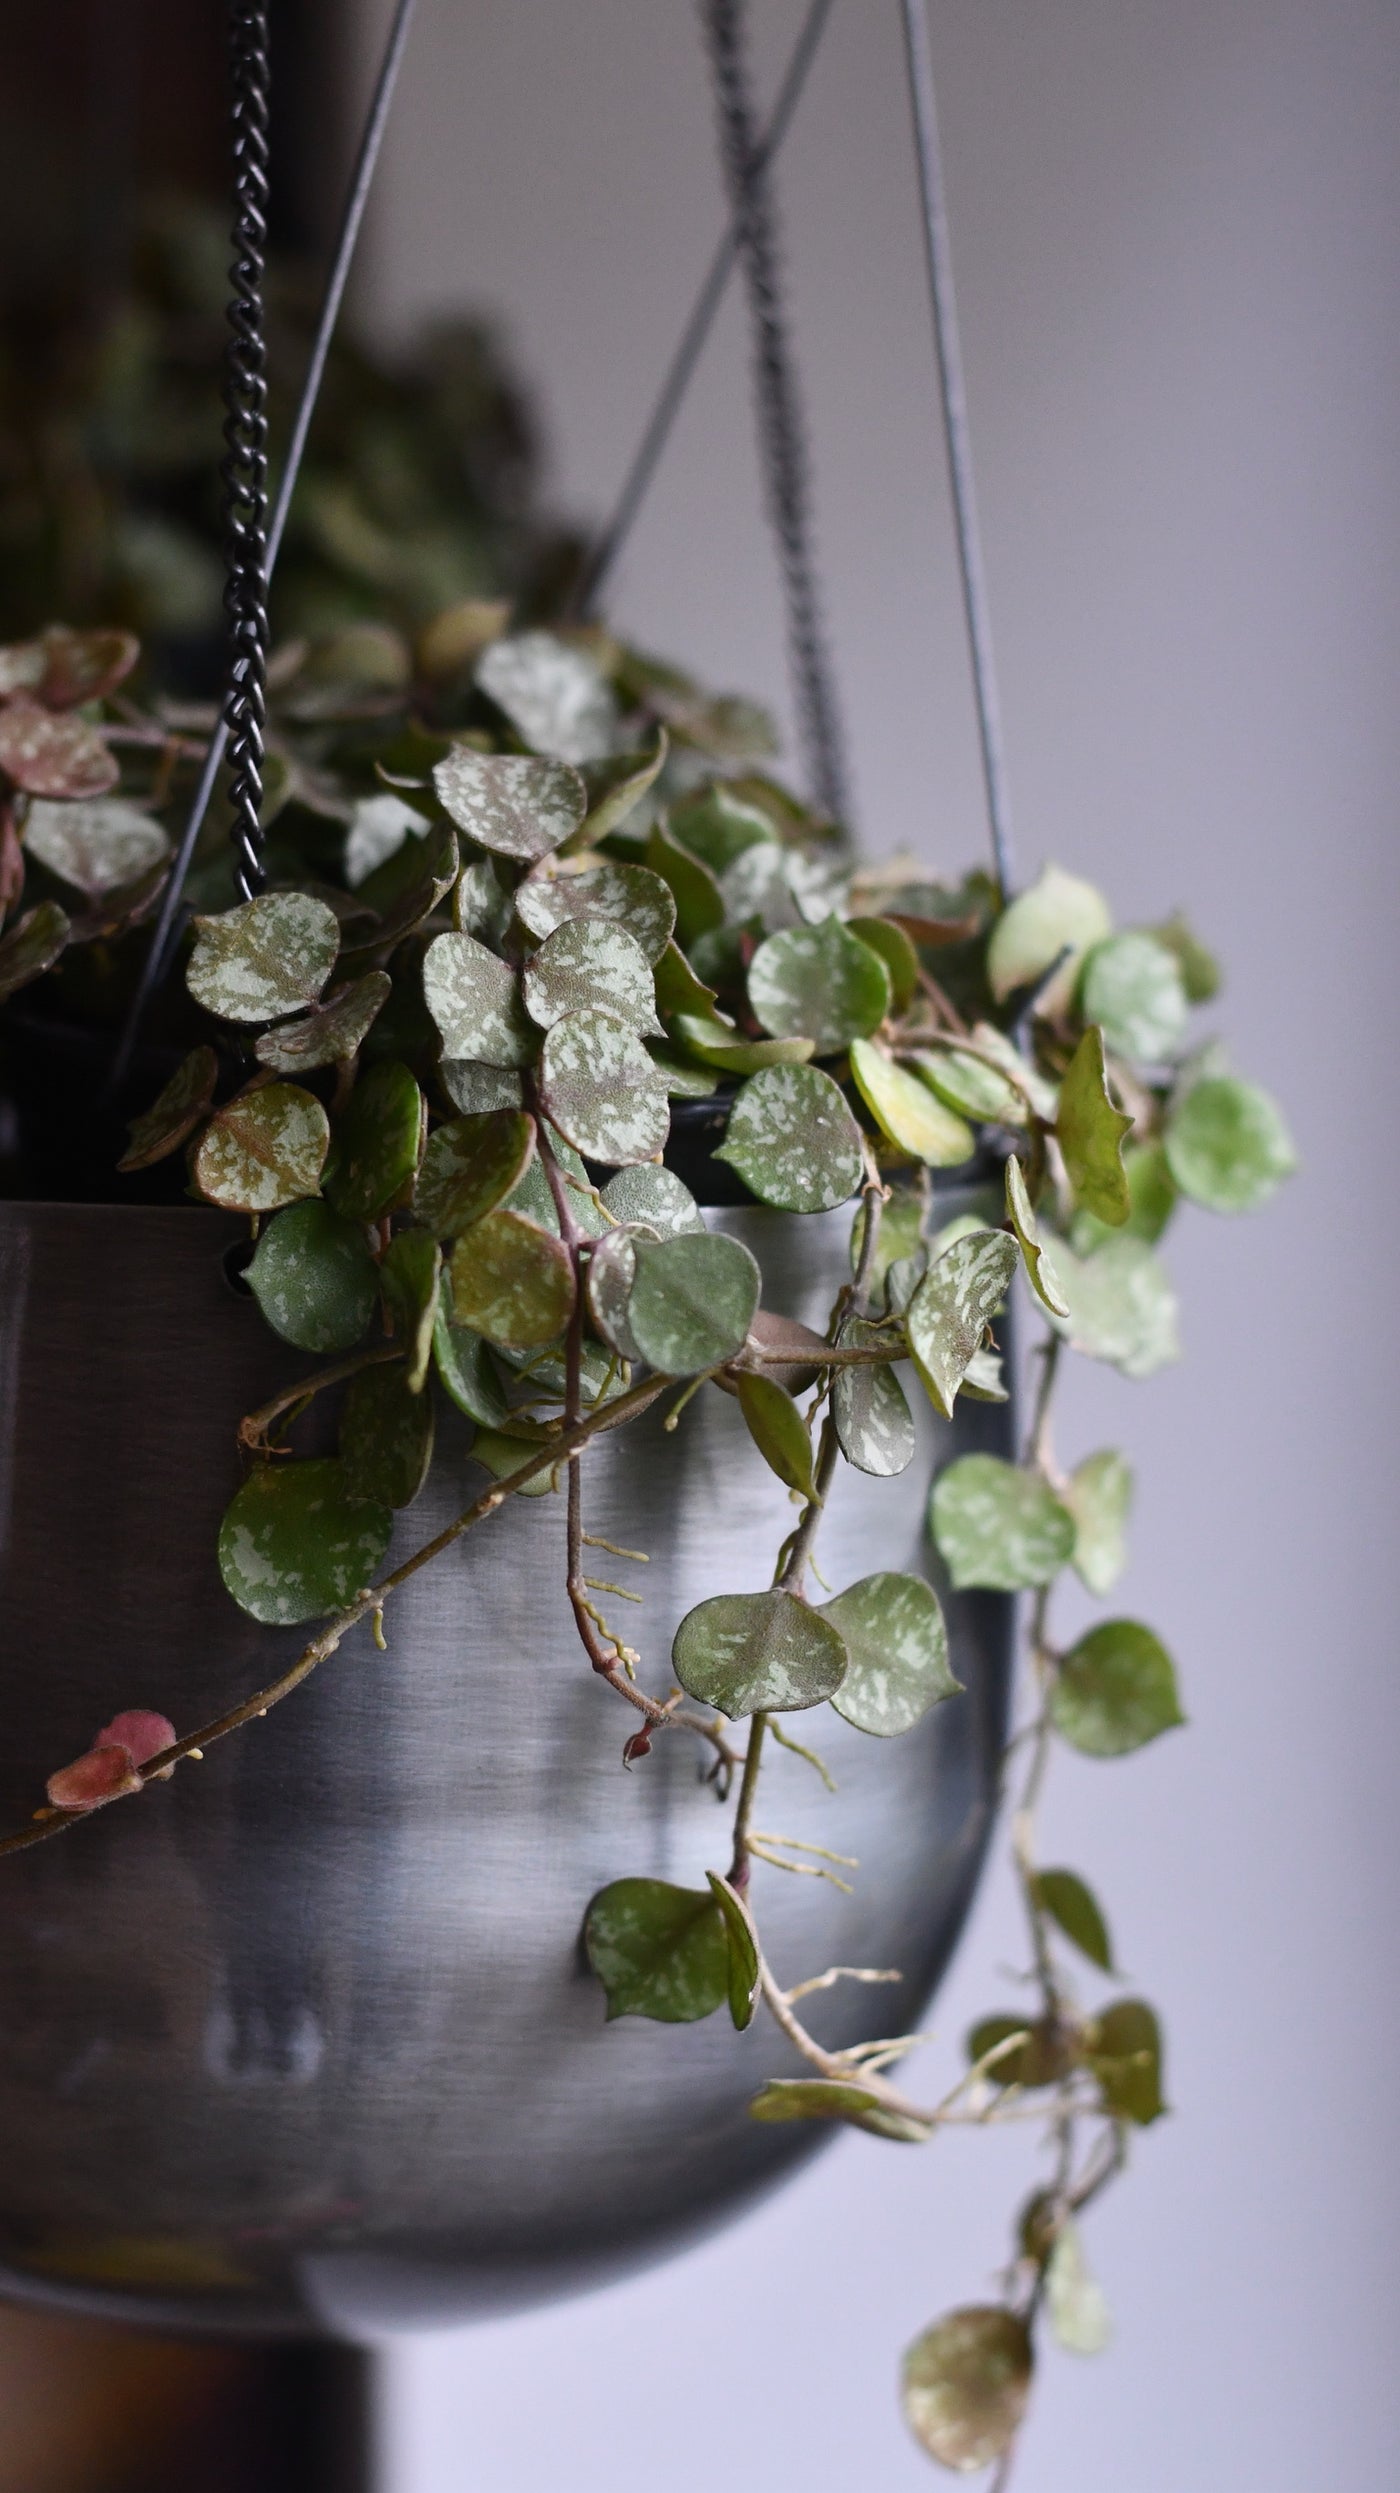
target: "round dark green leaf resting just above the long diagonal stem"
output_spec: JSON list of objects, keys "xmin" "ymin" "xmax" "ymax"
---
[{"xmin": 219, "ymin": 1458, "xmax": 394, "ymax": 1628}]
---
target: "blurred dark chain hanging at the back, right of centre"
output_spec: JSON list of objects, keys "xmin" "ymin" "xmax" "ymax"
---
[{"xmin": 700, "ymin": 0, "xmax": 849, "ymax": 823}]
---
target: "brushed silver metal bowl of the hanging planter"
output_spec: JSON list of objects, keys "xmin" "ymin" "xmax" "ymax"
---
[{"xmin": 0, "ymin": 1189, "xmax": 1011, "ymax": 2336}]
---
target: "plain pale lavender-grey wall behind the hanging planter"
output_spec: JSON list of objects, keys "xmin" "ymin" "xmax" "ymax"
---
[{"xmin": 351, "ymin": 0, "xmax": 1400, "ymax": 2493}]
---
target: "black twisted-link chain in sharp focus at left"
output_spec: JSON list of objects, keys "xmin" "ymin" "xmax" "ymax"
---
[{"xmin": 219, "ymin": 0, "xmax": 269, "ymax": 900}]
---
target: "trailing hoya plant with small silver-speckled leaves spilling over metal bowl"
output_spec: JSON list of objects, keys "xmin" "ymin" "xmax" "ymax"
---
[{"xmin": 0, "ymin": 608, "xmax": 1293, "ymax": 2471}]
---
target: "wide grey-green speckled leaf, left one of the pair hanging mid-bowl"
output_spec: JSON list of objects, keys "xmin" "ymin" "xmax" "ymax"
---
[{"xmin": 670, "ymin": 1593, "xmax": 847, "ymax": 1720}]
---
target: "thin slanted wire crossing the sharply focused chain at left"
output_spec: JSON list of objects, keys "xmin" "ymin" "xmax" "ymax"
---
[{"xmin": 107, "ymin": 0, "xmax": 419, "ymax": 1089}]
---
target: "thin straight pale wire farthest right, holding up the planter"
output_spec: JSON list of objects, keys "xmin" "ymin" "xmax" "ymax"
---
[{"xmin": 902, "ymin": 0, "xmax": 1011, "ymax": 900}]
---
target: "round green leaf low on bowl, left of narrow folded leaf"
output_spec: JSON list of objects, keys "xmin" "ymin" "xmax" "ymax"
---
[{"xmin": 583, "ymin": 1877, "xmax": 730, "ymax": 2024}]
